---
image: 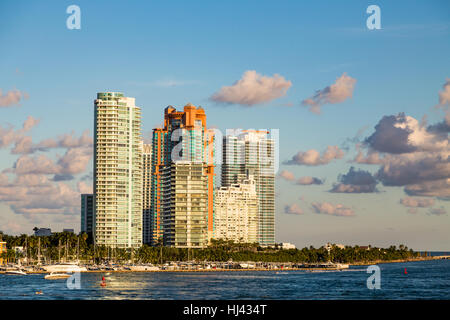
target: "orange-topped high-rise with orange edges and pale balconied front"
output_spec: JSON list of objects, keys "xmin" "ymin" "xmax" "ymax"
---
[{"xmin": 151, "ymin": 104, "xmax": 215, "ymax": 247}]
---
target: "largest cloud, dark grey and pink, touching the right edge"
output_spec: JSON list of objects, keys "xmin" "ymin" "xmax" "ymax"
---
[{"xmin": 354, "ymin": 109, "xmax": 450, "ymax": 199}]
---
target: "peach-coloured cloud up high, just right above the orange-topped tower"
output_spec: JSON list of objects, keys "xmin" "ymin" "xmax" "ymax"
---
[{"xmin": 210, "ymin": 70, "xmax": 292, "ymax": 106}]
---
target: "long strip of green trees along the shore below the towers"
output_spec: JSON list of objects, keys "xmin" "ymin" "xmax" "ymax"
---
[{"xmin": 0, "ymin": 232, "xmax": 420, "ymax": 264}]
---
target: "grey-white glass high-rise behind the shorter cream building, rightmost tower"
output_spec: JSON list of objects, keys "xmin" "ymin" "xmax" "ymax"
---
[{"xmin": 221, "ymin": 130, "xmax": 275, "ymax": 246}]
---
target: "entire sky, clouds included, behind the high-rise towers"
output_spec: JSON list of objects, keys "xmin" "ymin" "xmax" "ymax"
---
[{"xmin": 0, "ymin": 1, "xmax": 450, "ymax": 251}]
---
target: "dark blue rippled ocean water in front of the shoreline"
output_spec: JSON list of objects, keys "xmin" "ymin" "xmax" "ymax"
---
[{"xmin": 0, "ymin": 260, "xmax": 450, "ymax": 300}]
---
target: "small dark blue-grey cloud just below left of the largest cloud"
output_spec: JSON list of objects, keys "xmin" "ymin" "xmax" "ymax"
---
[{"xmin": 330, "ymin": 167, "xmax": 378, "ymax": 193}]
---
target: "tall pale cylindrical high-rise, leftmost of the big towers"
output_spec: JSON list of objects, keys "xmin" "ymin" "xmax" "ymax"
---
[{"xmin": 94, "ymin": 92, "xmax": 142, "ymax": 248}]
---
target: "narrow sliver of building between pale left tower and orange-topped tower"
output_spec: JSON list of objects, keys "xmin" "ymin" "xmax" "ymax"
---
[{"xmin": 142, "ymin": 144, "xmax": 153, "ymax": 244}]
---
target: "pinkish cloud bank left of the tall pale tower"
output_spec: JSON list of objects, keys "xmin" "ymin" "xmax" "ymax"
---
[{"xmin": 0, "ymin": 117, "xmax": 93, "ymax": 226}]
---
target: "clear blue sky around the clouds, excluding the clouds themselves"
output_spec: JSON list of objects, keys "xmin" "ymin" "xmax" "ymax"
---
[{"xmin": 0, "ymin": 1, "xmax": 450, "ymax": 250}]
